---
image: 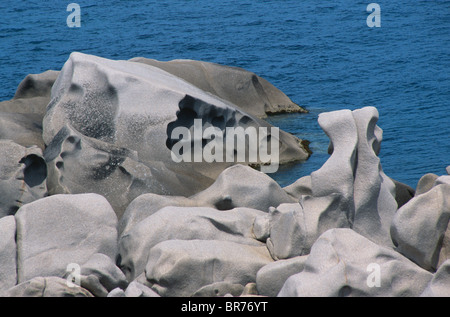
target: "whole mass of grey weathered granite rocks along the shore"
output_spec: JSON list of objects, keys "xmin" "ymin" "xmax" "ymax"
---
[{"xmin": 0, "ymin": 53, "xmax": 450, "ymax": 297}]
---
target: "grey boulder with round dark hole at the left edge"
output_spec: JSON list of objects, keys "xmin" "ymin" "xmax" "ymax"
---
[{"xmin": 0, "ymin": 140, "xmax": 47, "ymax": 218}]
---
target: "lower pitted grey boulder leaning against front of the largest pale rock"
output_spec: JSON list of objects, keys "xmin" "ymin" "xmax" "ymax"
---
[{"xmin": 44, "ymin": 125, "xmax": 213, "ymax": 219}]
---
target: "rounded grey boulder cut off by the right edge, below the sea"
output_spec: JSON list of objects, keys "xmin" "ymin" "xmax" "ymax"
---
[{"xmin": 391, "ymin": 184, "xmax": 450, "ymax": 271}]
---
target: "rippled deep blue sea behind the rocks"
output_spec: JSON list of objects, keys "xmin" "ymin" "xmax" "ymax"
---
[{"xmin": 0, "ymin": 0, "xmax": 450, "ymax": 187}]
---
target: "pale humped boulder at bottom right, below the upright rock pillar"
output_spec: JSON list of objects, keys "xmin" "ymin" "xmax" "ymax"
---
[{"xmin": 278, "ymin": 228, "xmax": 433, "ymax": 297}]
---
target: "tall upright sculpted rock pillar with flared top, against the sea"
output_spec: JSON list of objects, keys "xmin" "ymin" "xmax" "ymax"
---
[{"xmin": 311, "ymin": 107, "xmax": 397, "ymax": 246}]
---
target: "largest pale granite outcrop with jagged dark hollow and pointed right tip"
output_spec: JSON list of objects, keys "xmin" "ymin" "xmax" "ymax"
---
[{"xmin": 39, "ymin": 53, "xmax": 310, "ymax": 217}]
